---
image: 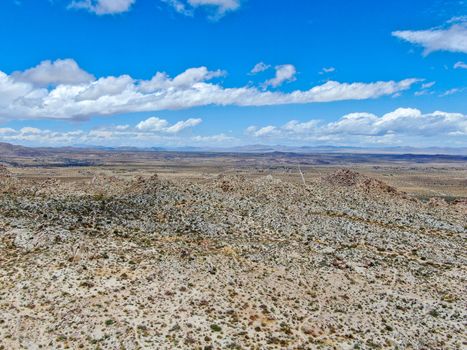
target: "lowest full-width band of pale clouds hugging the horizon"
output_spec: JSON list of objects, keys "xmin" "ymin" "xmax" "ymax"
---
[{"xmin": 0, "ymin": 108, "xmax": 467, "ymax": 147}]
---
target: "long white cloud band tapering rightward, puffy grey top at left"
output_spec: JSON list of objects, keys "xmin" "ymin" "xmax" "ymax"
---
[{"xmin": 0, "ymin": 60, "xmax": 419, "ymax": 120}]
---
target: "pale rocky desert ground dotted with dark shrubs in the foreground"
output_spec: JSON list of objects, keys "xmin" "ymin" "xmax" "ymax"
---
[{"xmin": 0, "ymin": 167, "xmax": 467, "ymax": 349}]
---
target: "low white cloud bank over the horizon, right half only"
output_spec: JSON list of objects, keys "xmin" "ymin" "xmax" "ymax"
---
[{"xmin": 245, "ymin": 108, "xmax": 467, "ymax": 145}]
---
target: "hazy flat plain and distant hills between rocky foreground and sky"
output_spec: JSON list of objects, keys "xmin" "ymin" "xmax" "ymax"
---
[{"xmin": 0, "ymin": 143, "xmax": 467, "ymax": 200}]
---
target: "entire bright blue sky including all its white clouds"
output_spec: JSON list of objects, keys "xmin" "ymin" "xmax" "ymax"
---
[{"xmin": 0, "ymin": 0, "xmax": 467, "ymax": 147}]
